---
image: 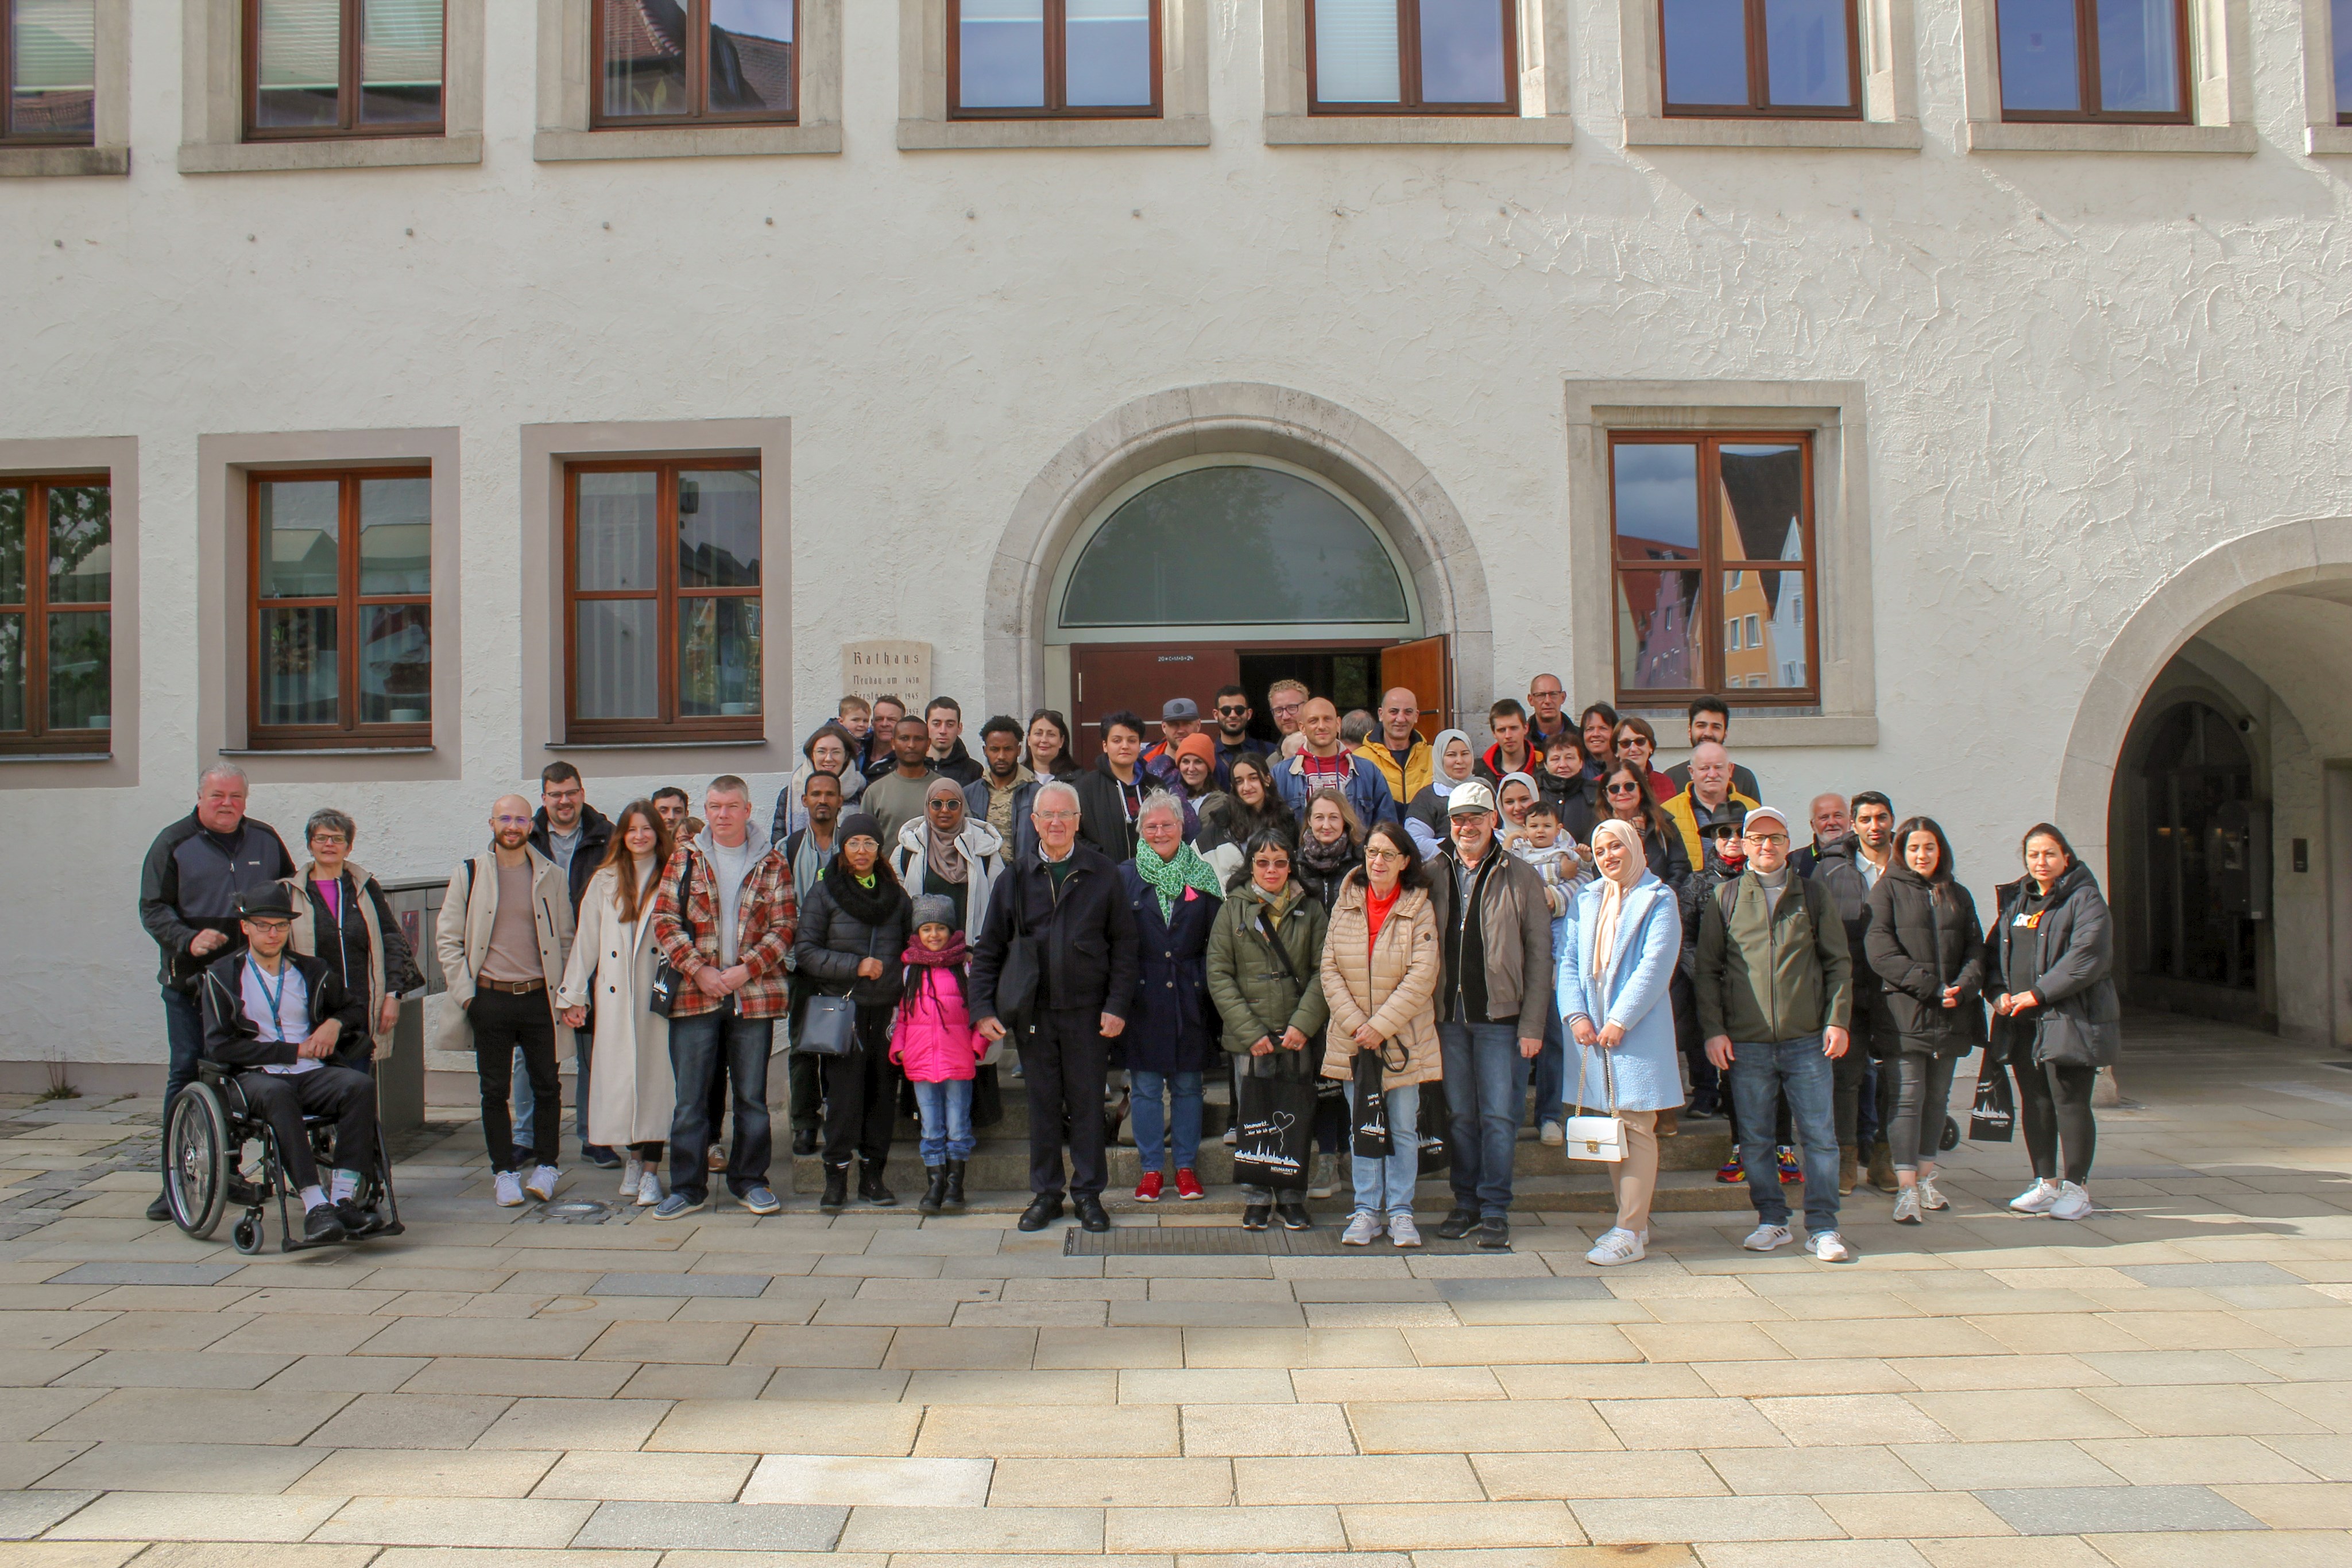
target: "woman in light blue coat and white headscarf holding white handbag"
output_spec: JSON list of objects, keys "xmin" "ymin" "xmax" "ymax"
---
[{"xmin": 1557, "ymin": 820, "xmax": 1682, "ymax": 1265}]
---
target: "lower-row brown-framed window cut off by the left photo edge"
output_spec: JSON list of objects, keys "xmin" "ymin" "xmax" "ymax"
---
[{"xmin": 0, "ymin": 475, "xmax": 115, "ymax": 754}]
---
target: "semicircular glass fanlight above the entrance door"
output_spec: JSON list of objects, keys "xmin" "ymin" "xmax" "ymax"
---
[{"xmin": 1061, "ymin": 466, "xmax": 1411, "ymax": 625}]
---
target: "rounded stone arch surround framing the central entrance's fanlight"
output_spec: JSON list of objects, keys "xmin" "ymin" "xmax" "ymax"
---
[{"xmin": 981, "ymin": 381, "xmax": 1494, "ymax": 729}]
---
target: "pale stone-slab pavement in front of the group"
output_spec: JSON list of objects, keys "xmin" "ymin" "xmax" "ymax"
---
[{"xmin": 0, "ymin": 1023, "xmax": 2352, "ymax": 1568}]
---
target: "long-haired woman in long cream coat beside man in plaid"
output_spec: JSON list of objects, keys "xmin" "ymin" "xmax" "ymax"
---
[{"xmin": 555, "ymin": 799, "xmax": 678, "ymax": 1209}]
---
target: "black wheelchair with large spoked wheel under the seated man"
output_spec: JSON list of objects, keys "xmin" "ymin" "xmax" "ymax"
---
[{"xmin": 163, "ymin": 1060, "xmax": 405, "ymax": 1255}]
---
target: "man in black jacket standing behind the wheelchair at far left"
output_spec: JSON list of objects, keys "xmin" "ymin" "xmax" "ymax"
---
[{"xmin": 139, "ymin": 762, "xmax": 294, "ymax": 1222}]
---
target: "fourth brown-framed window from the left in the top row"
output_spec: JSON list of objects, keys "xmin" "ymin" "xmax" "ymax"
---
[{"xmin": 948, "ymin": 0, "xmax": 1162, "ymax": 120}]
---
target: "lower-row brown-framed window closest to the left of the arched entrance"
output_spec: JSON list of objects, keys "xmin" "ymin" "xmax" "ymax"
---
[{"xmin": 564, "ymin": 458, "xmax": 764, "ymax": 743}]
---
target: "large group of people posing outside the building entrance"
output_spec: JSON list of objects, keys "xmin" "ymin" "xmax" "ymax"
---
[{"xmin": 141, "ymin": 675, "xmax": 2119, "ymax": 1265}]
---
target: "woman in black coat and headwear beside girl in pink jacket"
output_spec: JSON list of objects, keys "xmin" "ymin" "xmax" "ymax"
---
[{"xmin": 792, "ymin": 811, "xmax": 910, "ymax": 1213}]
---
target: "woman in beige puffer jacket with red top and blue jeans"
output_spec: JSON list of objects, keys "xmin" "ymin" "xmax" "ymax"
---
[{"xmin": 1322, "ymin": 823, "xmax": 1444, "ymax": 1246}]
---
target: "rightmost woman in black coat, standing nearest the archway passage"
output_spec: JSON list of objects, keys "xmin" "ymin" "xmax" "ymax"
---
[{"xmin": 1987, "ymin": 823, "xmax": 2124, "ymax": 1220}]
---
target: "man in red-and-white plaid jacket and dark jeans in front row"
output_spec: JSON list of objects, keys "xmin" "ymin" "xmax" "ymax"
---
[{"xmin": 654, "ymin": 773, "xmax": 800, "ymax": 1220}]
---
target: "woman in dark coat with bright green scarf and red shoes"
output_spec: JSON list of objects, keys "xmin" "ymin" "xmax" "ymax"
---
[{"xmin": 1117, "ymin": 790, "xmax": 1223, "ymax": 1203}]
